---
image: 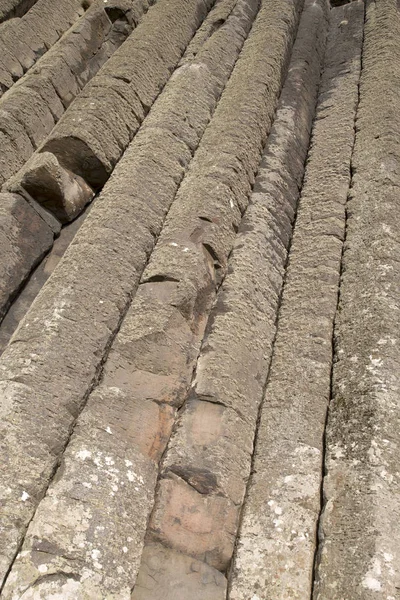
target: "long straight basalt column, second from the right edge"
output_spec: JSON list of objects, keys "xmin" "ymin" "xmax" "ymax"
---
[{"xmin": 228, "ymin": 1, "xmax": 364, "ymax": 600}]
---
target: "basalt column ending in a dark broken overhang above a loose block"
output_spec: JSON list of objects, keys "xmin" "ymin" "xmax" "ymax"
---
[{"xmin": 44, "ymin": 0, "xmax": 217, "ymax": 187}]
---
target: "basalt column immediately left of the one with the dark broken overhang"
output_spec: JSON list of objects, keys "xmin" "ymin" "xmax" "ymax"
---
[{"xmin": 0, "ymin": 0, "xmax": 147, "ymax": 185}]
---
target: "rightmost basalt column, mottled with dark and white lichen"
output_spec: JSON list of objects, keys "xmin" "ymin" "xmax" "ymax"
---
[{"xmin": 314, "ymin": 0, "xmax": 400, "ymax": 600}]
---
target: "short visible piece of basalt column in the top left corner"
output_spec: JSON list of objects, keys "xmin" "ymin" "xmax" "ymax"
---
[{"xmin": 0, "ymin": 0, "xmax": 85, "ymax": 89}]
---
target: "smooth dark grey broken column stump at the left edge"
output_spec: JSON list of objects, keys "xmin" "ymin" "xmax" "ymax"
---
[{"xmin": 0, "ymin": 193, "xmax": 53, "ymax": 319}]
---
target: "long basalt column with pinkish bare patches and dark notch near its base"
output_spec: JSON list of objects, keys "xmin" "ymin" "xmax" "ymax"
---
[{"xmin": 133, "ymin": 0, "xmax": 328, "ymax": 600}]
